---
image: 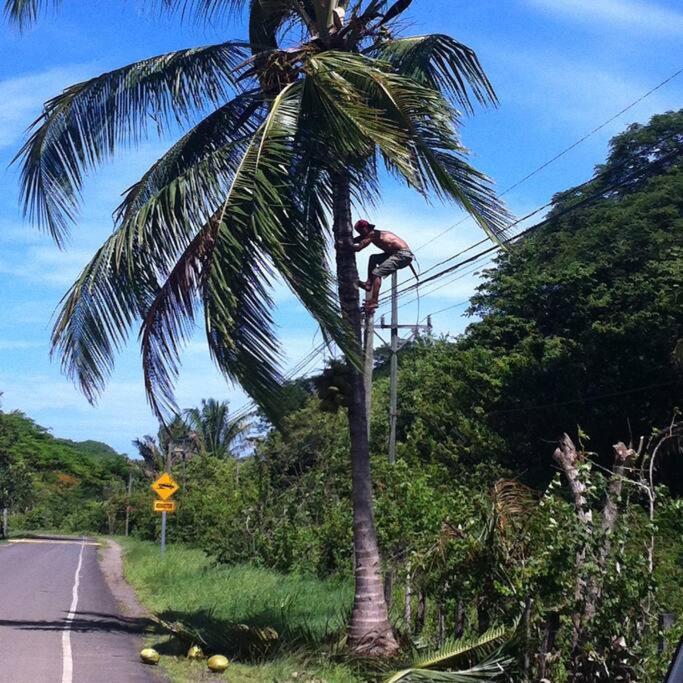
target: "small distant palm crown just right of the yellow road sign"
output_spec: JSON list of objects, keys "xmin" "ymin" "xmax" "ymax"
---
[{"xmin": 183, "ymin": 398, "xmax": 251, "ymax": 458}]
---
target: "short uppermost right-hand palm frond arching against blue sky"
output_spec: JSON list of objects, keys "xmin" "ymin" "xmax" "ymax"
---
[{"xmin": 371, "ymin": 34, "xmax": 498, "ymax": 112}]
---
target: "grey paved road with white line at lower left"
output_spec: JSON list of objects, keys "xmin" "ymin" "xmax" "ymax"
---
[{"xmin": 0, "ymin": 539, "xmax": 161, "ymax": 683}]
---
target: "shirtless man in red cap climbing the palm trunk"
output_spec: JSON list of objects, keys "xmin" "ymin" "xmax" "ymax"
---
[{"xmin": 336, "ymin": 220, "xmax": 415, "ymax": 313}]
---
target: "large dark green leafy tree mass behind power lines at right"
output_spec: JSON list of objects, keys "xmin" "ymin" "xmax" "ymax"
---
[{"xmin": 462, "ymin": 111, "xmax": 683, "ymax": 484}]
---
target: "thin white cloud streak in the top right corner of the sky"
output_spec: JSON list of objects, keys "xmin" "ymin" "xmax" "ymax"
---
[{"xmin": 527, "ymin": 0, "xmax": 683, "ymax": 35}]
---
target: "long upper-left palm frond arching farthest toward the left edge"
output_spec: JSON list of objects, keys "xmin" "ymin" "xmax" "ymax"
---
[{"xmin": 15, "ymin": 42, "xmax": 246, "ymax": 243}]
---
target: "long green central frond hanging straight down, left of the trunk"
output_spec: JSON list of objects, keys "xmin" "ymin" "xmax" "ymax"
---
[{"xmin": 202, "ymin": 83, "xmax": 302, "ymax": 419}]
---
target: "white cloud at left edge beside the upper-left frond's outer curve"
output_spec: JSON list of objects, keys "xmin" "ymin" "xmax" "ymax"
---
[{"xmin": 0, "ymin": 65, "xmax": 90, "ymax": 147}]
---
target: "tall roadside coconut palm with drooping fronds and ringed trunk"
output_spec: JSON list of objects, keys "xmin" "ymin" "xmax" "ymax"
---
[{"xmin": 5, "ymin": 0, "xmax": 506, "ymax": 655}]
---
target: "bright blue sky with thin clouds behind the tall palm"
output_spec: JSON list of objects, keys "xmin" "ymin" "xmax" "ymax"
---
[{"xmin": 0, "ymin": 0, "xmax": 683, "ymax": 452}]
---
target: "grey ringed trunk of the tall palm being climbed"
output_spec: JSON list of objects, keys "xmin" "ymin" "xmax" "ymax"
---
[{"xmin": 332, "ymin": 173, "xmax": 398, "ymax": 656}]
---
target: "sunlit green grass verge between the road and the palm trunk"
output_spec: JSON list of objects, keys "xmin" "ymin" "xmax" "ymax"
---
[{"xmin": 119, "ymin": 539, "xmax": 363, "ymax": 683}]
